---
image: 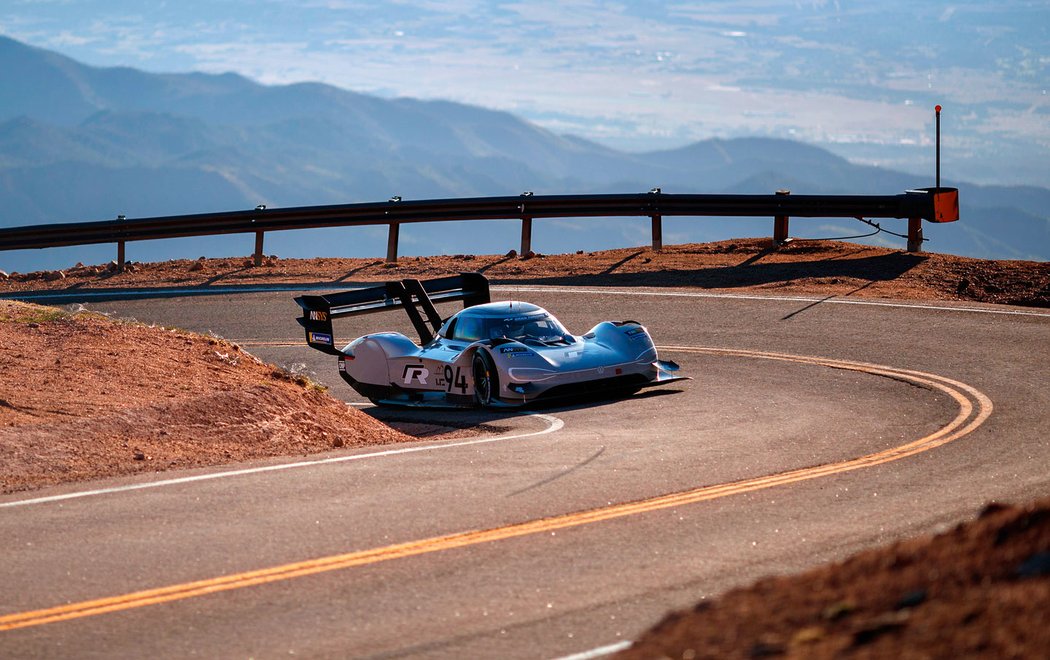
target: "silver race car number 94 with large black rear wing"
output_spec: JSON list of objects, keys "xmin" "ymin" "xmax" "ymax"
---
[{"xmin": 295, "ymin": 273, "xmax": 688, "ymax": 407}]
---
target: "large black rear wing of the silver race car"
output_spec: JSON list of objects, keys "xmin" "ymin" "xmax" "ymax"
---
[{"xmin": 295, "ymin": 273, "xmax": 489, "ymax": 356}]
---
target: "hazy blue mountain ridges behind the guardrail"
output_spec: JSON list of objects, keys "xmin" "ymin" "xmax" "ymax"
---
[{"xmin": 0, "ymin": 37, "xmax": 1050, "ymax": 271}]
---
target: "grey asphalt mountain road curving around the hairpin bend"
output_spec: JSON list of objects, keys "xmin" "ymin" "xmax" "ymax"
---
[{"xmin": 0, "ymin": 288, "xmax": 1050, "ymax": 658}]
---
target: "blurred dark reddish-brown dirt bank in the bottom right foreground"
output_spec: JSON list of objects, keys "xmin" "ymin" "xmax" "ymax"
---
[{"xmin": 618, "ymin": 501, "xmax": 1050, "ymax": 660}]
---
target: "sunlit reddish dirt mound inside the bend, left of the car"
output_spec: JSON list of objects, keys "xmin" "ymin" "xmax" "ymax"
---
[{"xmin": 0, "ymin": 301, "xmax": 412, "ymax": 492}]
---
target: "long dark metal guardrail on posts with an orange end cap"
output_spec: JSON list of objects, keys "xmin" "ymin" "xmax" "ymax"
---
[{"xmin": 0, "ymin": 188, "xmax": 959, "ymax": 271}]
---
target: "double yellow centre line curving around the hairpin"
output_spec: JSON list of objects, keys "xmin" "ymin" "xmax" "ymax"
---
[{"xmin": 0, "ymin": 346, "xmax": 992, "ymax": 631}]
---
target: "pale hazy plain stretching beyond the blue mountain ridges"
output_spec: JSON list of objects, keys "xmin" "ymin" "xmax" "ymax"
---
[{"xmin": 0, "ymin": 0, "xmax": 1050, "ymax": 185}]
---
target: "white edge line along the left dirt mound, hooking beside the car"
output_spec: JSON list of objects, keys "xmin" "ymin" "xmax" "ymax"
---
[{"xmin": 0, "ymin": 412, "xmax": 565, "ymax": 509}]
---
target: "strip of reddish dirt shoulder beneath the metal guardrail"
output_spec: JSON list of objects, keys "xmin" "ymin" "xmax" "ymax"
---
[{"xmin": 6, "ymin": 238, "xmax": 1050, "ymax": 307}]
